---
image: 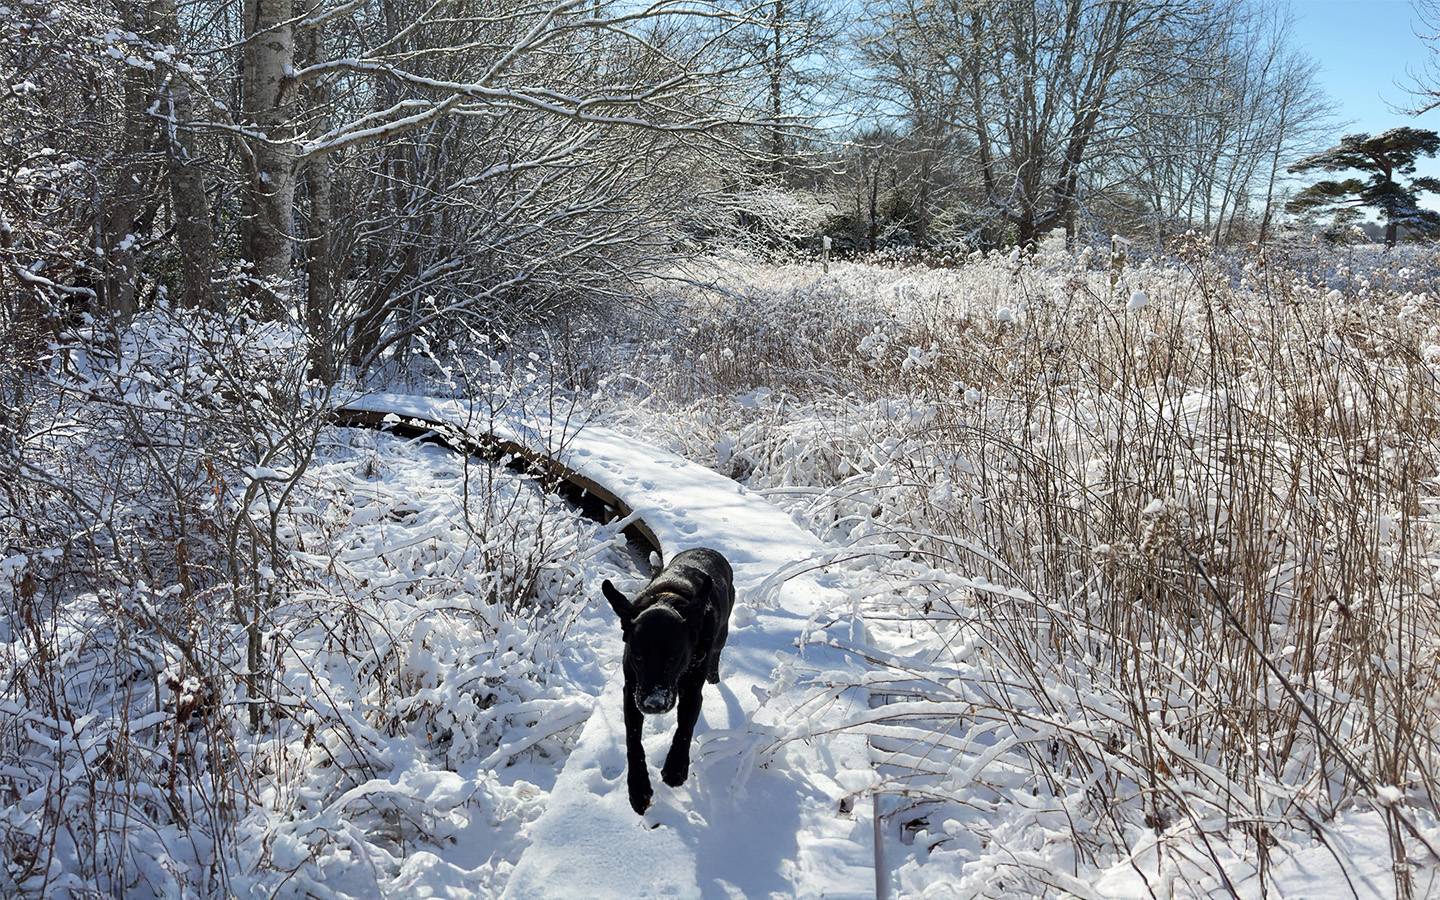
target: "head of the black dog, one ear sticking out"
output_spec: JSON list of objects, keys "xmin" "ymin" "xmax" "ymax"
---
[{"xmin": 600, "ymin": 580, "xmax": 701, "ymax": 716}]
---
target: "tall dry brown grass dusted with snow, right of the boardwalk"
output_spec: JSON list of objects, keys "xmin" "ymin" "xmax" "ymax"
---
[{"xmin": 590, "ymin": 240, "xmax": 1440, "ymax": 896}]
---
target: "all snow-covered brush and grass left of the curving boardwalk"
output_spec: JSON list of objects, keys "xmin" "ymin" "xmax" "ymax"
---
[{"xmin": 0, "ymin": 310, "xmax": 608, "ymax": 896}]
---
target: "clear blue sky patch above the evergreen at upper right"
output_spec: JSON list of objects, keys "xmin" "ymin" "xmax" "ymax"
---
[{"xmin": 1290, "ymin": 0, "xmax": 1440, "ymax": 177}]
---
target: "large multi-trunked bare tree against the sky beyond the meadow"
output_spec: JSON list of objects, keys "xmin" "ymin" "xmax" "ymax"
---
[{"xmin": 852, "ymin": 0, "xmax": 1195, "ymax": 243}]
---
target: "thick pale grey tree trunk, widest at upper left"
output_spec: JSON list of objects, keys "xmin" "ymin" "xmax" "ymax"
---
[{"xmin": 243, "ymin": 0, "xmax": 295, "ymax": 318}]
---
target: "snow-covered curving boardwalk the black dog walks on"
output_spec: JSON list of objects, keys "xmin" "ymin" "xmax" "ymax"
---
[{"xmin": 338, "ymin": 395, "xmax": 876, "ymax": 899}]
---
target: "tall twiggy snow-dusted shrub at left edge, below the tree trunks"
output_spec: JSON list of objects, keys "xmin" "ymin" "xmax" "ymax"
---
[{"xmin": 0, "ymin": 311, "xmax": 320, "ymax": 893}]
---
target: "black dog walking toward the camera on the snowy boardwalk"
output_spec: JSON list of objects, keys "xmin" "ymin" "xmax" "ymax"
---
[{"xmin": 600, "ymin": 549, "xmax": 734, "ymax": 814}]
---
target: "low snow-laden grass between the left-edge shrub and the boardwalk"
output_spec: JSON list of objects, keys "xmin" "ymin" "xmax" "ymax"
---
[{"xmin": 239, "ymin": 432, "xmax": 627, "ymax": 896}]
